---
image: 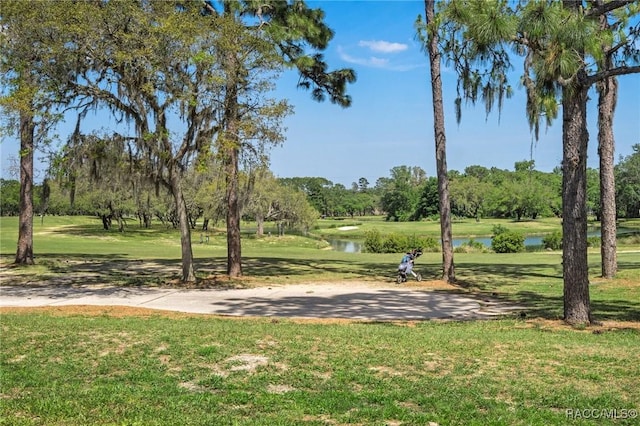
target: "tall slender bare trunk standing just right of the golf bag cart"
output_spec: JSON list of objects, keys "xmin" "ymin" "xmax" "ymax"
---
[{"xmin": 424, "ymin": 0, "xmax": 455, "ymax": 282}]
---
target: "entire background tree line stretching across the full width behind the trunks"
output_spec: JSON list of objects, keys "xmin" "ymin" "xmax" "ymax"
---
[{"xmin": 0, "ymin": 142, "xmax": 640, "ymax": 221}]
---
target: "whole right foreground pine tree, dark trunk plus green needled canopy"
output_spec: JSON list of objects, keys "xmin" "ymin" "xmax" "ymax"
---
[{"xmin": 440, "ymin": 0, "xmax": 640, "ymax": 323}]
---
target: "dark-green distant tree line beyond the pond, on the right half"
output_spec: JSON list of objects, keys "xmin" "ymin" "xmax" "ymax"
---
[{"xmin": 281, "ymin": 149, "xmax": 640, "ymax": 221}]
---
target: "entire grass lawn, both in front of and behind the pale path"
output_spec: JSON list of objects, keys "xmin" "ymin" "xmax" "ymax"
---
[{"xmin": 0, "ymin": 217, "xmax": 640, "ymax": 425}]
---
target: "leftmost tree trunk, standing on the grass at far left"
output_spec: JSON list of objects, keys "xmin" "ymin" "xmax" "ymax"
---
[{"xmin": 15, "ymin": 111, "xmax": 35, "ymax": 265}]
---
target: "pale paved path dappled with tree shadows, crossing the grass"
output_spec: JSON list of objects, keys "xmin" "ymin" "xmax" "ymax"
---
[{"xmin": 0, "ymin": 284, "xmax": 515, "ymax": 320}]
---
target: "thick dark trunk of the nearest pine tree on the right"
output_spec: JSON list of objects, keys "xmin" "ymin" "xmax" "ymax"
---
[{"xmin": 562, "ymin": 83, "xmax": 591, "ymax": 324}]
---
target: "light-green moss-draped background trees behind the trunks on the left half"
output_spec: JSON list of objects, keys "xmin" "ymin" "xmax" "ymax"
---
[{"xmin": 0, "ymin": 163, "xmax": 319, "ymax": 234}]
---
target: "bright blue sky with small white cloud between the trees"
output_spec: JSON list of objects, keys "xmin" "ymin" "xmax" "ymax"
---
[{"xmin": 0, "ymin": 0, "xmax": 640, "ymax": 187}]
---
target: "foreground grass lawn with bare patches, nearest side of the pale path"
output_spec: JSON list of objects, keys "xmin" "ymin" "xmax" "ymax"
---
[{"xmin": 0, "ymin": 308, "xmax": 640, "ymax": 425}]
